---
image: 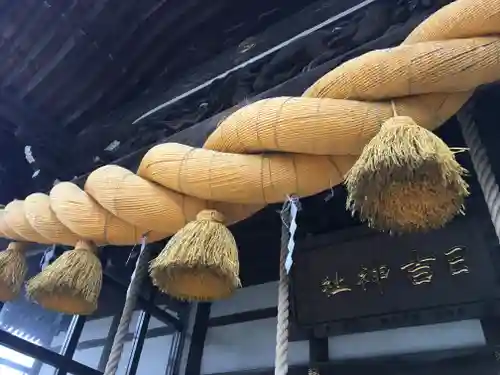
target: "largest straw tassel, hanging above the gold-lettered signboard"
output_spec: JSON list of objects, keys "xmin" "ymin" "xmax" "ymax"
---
[{"xmin": 345, "ymin": 103, "xmax": 469, "ymax": 232}]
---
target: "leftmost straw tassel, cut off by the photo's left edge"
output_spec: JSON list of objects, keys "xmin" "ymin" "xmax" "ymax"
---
[{"xmin": 0, "ymin": 242, "xmax": 28, "ymax": 302}]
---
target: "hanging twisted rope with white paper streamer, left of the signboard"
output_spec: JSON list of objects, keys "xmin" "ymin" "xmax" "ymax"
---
[{"xmin": 274, "ymin": 201, "xmax": 290, "ymax": 375}]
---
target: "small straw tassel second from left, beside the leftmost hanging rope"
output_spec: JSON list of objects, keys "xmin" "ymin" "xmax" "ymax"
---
[{"xmin": 26, "ymin": 241, "xmax": 102, "ymax": 315}]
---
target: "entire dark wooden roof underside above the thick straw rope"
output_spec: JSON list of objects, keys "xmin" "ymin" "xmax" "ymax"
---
[{"xmin": 0, "ymin": 0, "xmax": 447, "ymax": 203}]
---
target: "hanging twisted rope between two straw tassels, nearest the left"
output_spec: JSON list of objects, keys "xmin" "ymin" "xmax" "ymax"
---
[{"xmin": 104, "ymin": 238, "xmax": 149, "ymax": 375}]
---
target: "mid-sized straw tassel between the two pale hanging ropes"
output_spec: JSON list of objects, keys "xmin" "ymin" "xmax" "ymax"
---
[{"xmin": 150, "ymin": 210, "xmax": 240, "ymax": 301}]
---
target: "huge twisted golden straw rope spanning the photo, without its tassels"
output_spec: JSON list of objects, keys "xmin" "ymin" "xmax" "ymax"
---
[{"xmin": 0, "ymin": 0, "xmax": 500, "ymax": 245}]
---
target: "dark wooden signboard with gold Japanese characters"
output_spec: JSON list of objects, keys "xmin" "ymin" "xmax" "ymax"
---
[{"xmin": 291, "ymin": 217, "xmax": 500, "ymax": 334}]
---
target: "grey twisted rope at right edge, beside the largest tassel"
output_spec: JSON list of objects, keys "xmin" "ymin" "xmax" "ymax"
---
[{"xmin": 457, "ymin": 103, "xmax": 500, "ymax": 240}]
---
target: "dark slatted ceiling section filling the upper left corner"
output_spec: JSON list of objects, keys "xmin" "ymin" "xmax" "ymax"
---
[{"xmin": 0, "ymin": 0, "xmax": 316, "ymax": 129}]
